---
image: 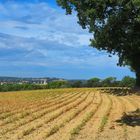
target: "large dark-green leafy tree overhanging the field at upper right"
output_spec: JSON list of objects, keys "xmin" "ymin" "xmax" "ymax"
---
[{"xmin": 57, "ymin": 0, "xmax": 140, "ymax": 87}]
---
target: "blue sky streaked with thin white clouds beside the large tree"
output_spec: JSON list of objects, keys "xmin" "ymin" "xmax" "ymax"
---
[{"xmin": 0, "ymin": 0, "xmax": 134, "ymax": 79}]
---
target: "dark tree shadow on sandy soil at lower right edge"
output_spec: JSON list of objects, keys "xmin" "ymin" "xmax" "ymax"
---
[{"xmin": 116, "ymin": 109, "xmax": 140, "ymax": 127}]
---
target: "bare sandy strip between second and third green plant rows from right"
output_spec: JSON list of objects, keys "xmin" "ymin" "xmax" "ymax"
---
[{"xmin": 44, "ymin": 92, "xmax": 100, "ymax": 140}]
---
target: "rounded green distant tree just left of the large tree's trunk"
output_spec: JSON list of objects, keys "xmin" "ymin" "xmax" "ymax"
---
[{"xmin": 120, "ymin": 76, "xmax": 136, "ymax": 87}]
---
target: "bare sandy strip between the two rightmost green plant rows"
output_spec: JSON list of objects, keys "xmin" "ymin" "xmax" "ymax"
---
[{"xmin": 76, "ymin": 94, "xmax": 110, "ymax": 140}]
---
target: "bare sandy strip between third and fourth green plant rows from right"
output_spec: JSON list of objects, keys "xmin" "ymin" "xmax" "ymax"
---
[{"xmin": 20, "ymin": 92, "xmax": 92, "ymax": 140}]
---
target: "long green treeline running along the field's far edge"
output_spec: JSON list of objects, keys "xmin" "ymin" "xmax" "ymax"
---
[{"xmin": 0, "ymin": 76, "xmax": 136, "ymax": 92}]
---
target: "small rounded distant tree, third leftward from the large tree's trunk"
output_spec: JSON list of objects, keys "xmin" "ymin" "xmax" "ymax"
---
[{"xmin": 87, "ymin": 78, "xmax": 100, "ymax": 87}]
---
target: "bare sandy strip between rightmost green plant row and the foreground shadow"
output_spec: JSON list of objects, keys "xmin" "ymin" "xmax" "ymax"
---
[{"xmin": 98, "ymin": 96, "xmax": 125, "ymax": 140}]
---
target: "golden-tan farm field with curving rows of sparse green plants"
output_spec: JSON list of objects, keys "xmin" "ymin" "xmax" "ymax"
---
[{"xmin": 0, "ymin": 88, "xmax": 140, "ymax": 140}]
